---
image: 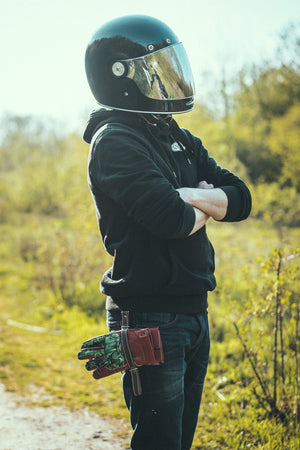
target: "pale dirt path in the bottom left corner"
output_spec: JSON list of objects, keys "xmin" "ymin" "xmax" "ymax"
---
[{"xmin": 0, "ymin": 384, "xmax": 129, "ymax": 450}]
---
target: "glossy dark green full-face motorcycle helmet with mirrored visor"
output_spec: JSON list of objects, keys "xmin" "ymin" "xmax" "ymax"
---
[{"xmin": 85, "ymin": 15, "xmax": 195, "ymax": 114}]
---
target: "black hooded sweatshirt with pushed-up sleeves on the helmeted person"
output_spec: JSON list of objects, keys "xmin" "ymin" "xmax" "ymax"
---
[{"xmin": 84, "ymin": 110, "xmax": 251, "ymax": 313}]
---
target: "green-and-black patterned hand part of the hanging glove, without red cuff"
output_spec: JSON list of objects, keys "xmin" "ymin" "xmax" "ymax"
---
[{"xmin": 78, "ymin": 333, "xmax": 126, "ymax": 372}]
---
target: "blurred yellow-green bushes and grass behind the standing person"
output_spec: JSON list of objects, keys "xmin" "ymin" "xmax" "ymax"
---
[{"xmin": 0, "ymin": 22, "xmax": 300, "ymax": 449}]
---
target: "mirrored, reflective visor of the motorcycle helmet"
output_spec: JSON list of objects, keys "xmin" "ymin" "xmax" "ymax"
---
[{"xmin": 122, "ymin": 43, "xmax": 194, "ymax": 100}]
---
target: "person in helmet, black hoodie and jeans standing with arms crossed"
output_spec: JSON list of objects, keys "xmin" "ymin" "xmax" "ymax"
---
[{"xmin": 84, "ymin": 16, "xmax": 251, "ymax": 450}]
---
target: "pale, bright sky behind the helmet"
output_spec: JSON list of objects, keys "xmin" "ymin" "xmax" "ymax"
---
[{"xmin": 0, "ymin": 0, "xmax": 300, "ymax": 129}]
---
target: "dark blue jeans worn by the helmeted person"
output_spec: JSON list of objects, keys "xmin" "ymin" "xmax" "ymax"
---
[{"xmin": 107, "ymin": 310, "xmax": 210, "ymax": 450}]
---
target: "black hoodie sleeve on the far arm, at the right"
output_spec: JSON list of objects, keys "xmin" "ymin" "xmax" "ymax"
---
[{"xmin": 189, "ymin": 132, "xmax": 252, "ymax": 222}]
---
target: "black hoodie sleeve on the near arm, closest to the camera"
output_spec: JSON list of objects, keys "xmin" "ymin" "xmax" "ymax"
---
[{"xmin": 88, "ymin": 125, "xmax": 195, "ymax": 239}]
